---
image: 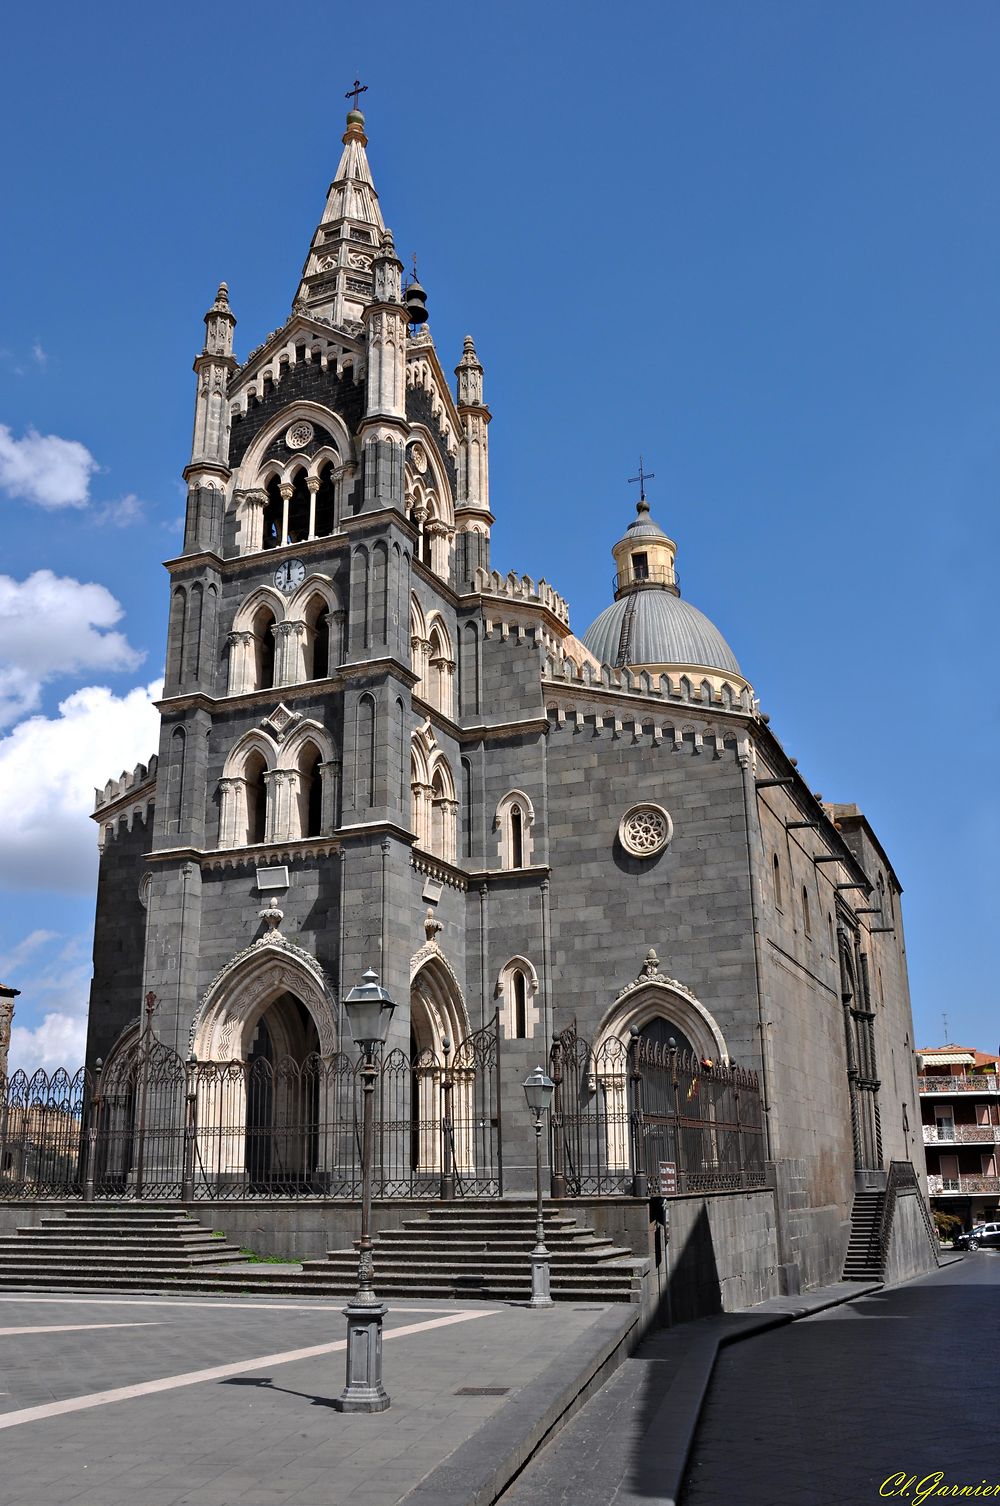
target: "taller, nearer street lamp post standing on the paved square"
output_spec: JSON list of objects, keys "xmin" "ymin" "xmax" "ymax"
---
[{"xmin": 333, "ymin": 967, "xmax": 396, "ymax": 1413}]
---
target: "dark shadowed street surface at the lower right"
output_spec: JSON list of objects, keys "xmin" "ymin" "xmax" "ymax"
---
[{"xmin": 681, "ymin": 1251, "xmax": 1000, "ymax": 1506}]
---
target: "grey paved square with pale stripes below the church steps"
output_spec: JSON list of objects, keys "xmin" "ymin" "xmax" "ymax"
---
[{"xmin": 0, "ymin": 1294, "xmax": 637, "ymax": 1506}]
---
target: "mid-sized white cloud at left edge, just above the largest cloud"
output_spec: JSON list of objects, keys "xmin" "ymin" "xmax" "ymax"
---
[{"xmin": 0, "ymin": 569, "xmax": 145, "ymax": 727}]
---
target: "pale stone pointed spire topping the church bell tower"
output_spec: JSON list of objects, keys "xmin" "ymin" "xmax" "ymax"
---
[{"xmin": 295, "ymin": 110, "xmax": 386, "ymax": 328}]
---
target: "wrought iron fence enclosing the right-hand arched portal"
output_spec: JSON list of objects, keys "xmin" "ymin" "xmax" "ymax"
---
[{"xmin": 551, "ymin": 1026, "xmax": 765, "ymax": 1197}]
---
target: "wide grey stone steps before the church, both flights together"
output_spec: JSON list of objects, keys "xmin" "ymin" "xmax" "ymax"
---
[{"xmin": 0, "ymin": 1202, "xmax": 648, "ymax": 1303}]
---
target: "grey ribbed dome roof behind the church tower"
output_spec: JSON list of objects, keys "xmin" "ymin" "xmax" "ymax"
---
[{"xmin": 583, "ymin": 587, "xmax": 742, "ymax": 678}]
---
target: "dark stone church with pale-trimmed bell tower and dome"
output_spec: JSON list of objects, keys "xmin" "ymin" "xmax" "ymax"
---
[{"xmin": 87, "ymin": 97, "xmax": 939, "ymax": 1289}]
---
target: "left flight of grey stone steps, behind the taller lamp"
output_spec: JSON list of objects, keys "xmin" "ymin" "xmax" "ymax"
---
[{"xmin": 0, "ymin": 1203, "xmax": 245, "ymax": 1291}]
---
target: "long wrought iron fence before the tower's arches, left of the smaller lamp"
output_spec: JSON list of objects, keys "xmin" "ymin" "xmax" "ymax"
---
[{"xmin": 0, "ymin": 1020, "xmax": 503, "ymax": 1202}]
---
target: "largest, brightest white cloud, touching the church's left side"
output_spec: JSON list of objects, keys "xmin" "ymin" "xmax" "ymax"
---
[{"xmin": 0, "ymin": 681, "xmax": 163, "ymax": 893}]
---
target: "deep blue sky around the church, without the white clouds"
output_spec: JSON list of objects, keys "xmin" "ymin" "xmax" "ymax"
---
[{"xmin": 0, "ymin": 0, "xmax": 1000, "ymax": 1065}]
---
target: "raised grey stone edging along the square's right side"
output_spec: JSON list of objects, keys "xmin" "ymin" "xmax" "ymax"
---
[{"xmin": 398, "ymin": 1304, "xmax": 640, "ymax": 1506}]
